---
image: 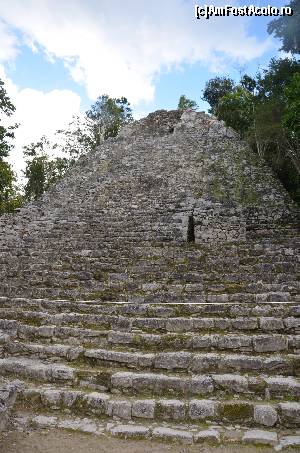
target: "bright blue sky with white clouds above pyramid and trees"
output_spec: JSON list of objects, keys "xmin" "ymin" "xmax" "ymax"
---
[{"xmin": 0, "ymin": 0, "xmax": 288, "ymax": 172}]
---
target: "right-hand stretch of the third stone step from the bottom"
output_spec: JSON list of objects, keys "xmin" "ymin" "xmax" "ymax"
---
[{"xmin": 110, "ymin": 371, "xmax": 299, "ymax": 401}]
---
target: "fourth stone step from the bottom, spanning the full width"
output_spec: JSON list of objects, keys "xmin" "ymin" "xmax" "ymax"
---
[{"xmin": 2, "ymin": 336, "xmax": 300, "ymax": 376}]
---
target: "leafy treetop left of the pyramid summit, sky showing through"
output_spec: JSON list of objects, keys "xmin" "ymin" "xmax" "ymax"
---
[{"xmin": 86, "ymin": 94, "xmax": 133, "ymax": 146}]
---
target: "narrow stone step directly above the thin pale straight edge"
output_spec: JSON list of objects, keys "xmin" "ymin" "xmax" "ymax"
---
[{"xmin": 1, "ymin": 279, "xmax": 300, "ymax": 304}]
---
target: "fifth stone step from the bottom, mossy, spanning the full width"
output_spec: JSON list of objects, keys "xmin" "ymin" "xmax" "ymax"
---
[{"xmin": 0, "ymin": 319, "xmax": 300, "ymax": 354}]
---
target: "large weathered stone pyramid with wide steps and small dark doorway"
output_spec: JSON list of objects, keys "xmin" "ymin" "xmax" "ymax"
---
[{"xmin": 0, "ymin": 111, "xmax": 300, "ymax": 448}]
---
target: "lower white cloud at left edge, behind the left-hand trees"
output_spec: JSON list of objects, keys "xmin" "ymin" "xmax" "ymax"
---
[{"xmin": 0, "ymin": 66, "xmax": 81, "ymax": 175}]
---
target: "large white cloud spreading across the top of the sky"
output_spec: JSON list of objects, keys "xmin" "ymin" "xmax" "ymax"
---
[{"xmin": 0, "ymin": 0, "xmax": 271, "ymax": 104}]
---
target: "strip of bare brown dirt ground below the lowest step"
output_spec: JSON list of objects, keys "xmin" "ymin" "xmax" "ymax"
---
[{"xmin": 0, "ymin": 430, "xmax": 288, "ymax": 453}]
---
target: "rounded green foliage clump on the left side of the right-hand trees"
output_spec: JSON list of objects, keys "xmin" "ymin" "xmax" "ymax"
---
[{"xmin": 215, "ymin": 86, "xmax": 253, "ymax": 137}]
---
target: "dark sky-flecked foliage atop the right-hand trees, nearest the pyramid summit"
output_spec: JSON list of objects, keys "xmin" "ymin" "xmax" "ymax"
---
[{"xmin": 202, "ymin": 77, "xmax": 234, "ymax": 113}]
